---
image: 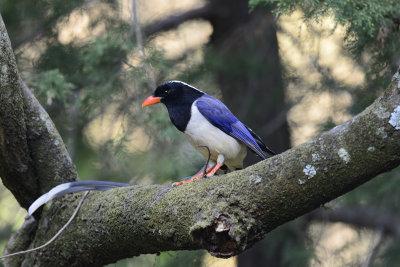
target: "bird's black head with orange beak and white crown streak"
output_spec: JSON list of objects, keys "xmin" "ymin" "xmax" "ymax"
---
[{"xmin": 142, "ymin": 81, "xmax": 204, "ymax": 108}]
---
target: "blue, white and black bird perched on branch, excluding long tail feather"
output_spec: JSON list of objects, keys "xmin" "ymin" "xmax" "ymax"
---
[{"xmin": 142, "ymin": 81, "xmax": 276, "ymax": 186}]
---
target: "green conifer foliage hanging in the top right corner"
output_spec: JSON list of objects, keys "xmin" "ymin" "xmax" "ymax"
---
[{"xmin": 249, "ymin": 0, "xmax": 400, "ymax": 105}]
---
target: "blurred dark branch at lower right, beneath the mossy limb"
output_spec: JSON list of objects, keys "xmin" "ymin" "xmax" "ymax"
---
[{"xmin": 306, "ymin": 206, "xmax": 400, "ymax": 237}]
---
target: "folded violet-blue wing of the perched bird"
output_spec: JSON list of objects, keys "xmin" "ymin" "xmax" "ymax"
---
[{"xmin": 196, "ymin": 94, "xmax": 267, "ymax": 159}]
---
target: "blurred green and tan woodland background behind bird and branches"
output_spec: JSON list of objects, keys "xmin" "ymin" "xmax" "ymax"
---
[{"xmin": 0, "ymin": 0, "xmax": 400, "ymax": 267}]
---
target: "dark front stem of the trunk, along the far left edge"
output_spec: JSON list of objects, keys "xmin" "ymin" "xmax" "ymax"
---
[{"xmin": 0, "ymin": 15, "xmax": 40, "ymax": 208}]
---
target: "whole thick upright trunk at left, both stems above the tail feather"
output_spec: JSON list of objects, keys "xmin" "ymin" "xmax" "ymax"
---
[{"xmin": 0, "ymin": 16, "xmax": 77, "ymax": 208}]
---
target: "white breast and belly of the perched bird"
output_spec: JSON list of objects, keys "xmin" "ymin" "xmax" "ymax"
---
[{"xmin": 184, "ymin": 102, "xmax": 247, "ymax": 170}]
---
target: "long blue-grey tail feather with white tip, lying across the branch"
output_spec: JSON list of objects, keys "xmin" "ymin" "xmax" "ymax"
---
[{"xmin": 28, "ymin": 181, "xmax": 131, "ymax": 215}]
